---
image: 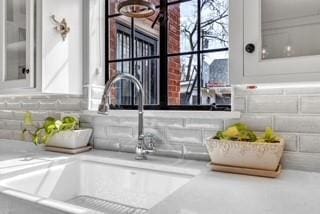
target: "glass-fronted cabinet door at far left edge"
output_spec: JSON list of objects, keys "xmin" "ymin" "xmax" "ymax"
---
[{"xmin": 0, "ymin": 0, "xmax": 35, "ymax": 89}]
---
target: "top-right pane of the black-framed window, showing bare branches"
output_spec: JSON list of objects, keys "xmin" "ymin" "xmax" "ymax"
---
[{"xmin": 200, "ymin": 0, "xmax": 229, "ymax": 50}]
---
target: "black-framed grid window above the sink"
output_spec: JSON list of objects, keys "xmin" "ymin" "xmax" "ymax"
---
[{"xmin": 106, "ymin": 0, "xmax": 231, "ymax": 110}]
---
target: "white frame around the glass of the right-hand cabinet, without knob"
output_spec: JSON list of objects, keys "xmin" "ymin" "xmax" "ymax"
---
[{"xmin": 229, "ymin": 0, "xmax": 320, "ymax": 84}]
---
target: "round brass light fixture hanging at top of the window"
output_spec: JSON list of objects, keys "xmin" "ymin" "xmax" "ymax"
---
[{"xmin": 118, "ymin": 0, "xmax": 156, "ymax": 18}]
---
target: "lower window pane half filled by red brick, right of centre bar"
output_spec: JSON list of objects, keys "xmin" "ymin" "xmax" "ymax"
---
[{"xmin": 168, "ymin": 55, "xmax": 198, "ymax": 105}]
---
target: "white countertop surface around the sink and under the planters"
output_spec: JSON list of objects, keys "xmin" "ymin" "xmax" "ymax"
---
[{"xmin": 0, "ymin": 142, "xmax": 320, "ymax": 214}]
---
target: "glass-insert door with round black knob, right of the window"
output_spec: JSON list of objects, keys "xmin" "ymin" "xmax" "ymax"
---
[{"xmin": 243, "ymin": 0, "xmax": 320, "ymax": 80}]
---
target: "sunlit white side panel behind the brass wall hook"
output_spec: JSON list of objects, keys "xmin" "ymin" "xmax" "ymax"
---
[{"xmin": 42, "ymin": 0, "xmax": 83, "ymax": 94}]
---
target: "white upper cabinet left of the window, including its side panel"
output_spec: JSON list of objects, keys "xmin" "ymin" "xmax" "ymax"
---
[{"xmin": 0, "ymin": 0, "xmax": 84, "ymax": 95}]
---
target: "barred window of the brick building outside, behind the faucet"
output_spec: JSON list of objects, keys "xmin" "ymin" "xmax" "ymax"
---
[{"xmin": 116, "ymin": 24, "xmax": 159, "ymax": 105}]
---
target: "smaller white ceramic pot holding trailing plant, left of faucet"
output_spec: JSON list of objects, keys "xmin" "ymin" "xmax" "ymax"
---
[{"xmin": 47, "ymin": 129, "xmax": 92, "ymax": 149}]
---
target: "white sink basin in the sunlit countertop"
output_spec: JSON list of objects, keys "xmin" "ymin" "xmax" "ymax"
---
[{"xmin": 0, "ymin": 156, "xmax": 193, "ymax": 213}]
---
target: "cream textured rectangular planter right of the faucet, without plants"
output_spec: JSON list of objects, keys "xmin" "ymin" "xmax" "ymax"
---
[{"xmin": 207, "ymin": 138, "xmax": 284, "ymax": 171}]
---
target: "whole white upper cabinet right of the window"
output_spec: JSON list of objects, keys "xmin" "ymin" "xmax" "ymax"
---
[{"xmin": 230, "ymin": 0, "xmax": 320, "ymax": 84}]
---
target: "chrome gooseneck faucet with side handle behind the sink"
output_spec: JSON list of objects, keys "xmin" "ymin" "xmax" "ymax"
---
[{"xmin": 98, "ymin": 73, "xmax": 155, "ymax": 160}]
